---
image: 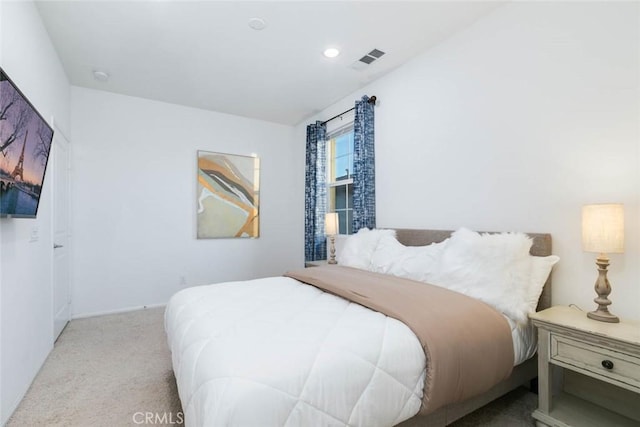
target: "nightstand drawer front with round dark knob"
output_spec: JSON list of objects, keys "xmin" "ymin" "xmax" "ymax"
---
[{"xmin": 549, "ymin": 333, "xmax": 640, "ymax": 390}]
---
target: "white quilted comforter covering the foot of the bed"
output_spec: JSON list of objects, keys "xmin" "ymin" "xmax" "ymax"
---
[{"xmin": 165, "ymin": 277, "xmax": 425, "ymax": 427}]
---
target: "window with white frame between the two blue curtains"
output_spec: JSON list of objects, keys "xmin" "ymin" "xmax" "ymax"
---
[{"xmin": 327, "ymin": 123, "xmax": 354, "ymax": 234}]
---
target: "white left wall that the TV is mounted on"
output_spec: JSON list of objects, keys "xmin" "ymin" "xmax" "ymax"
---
[{"xmin": 0, "ymin": 1, "xmax": 69, "ymax": 423}]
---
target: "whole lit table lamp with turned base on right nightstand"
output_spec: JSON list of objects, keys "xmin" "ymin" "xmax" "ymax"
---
[{"xmin": 582, "ymin": 203, "xmax": 624, "ymax": 323}]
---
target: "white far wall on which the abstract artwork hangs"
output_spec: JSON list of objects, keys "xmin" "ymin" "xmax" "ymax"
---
[{"xmin": 71, "ymin": 87, "xmax": 304, "ymax": 316}]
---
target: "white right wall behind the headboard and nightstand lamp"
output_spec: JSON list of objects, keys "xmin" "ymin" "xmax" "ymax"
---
[{"xmin": 296, "ymin": 2, "xmax": 640, "ymax": 318}]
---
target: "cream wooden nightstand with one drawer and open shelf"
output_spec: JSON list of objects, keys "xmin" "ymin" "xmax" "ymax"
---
[{"xmin": 529, "ymin": 306, "xmax": 640, "ymax": 427}]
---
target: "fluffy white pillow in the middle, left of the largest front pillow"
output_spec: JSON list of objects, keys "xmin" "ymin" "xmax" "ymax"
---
[{"xmin": 371, "ymin": 235, "xmax": 446, "ymax": 282}]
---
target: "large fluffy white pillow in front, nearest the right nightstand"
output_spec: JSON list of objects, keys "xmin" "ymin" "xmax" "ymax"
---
[{"xmin": 430, "ymin": 228, "xmax": 533, "ymax": 323}]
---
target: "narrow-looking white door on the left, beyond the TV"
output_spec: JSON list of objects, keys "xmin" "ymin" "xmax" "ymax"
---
[{"xmin": 50, "ymin": 128, "xmax": 71, "ymax": 341}]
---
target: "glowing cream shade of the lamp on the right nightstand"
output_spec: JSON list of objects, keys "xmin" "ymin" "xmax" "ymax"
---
[{"xmin": 582, "ymin": 203, "xmax": 624, "ymax": 254}]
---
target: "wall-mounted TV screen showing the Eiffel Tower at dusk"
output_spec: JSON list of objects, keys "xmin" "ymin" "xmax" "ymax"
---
[{"xmin": 0, "ymin": 68, "xmax": 53, "ymax": 218}]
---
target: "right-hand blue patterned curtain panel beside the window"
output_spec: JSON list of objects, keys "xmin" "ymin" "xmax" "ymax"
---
[{"xmin": 353, "ymin": 95, "xmax": 376, "ymax": 233}]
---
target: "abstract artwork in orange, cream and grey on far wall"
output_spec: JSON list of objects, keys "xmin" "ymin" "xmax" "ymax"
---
[{"xmin": 197, "ymin": 151, "xmax": 260, "ymax": 239}]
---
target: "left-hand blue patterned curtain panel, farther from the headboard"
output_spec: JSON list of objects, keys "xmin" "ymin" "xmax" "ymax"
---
[{"xmin": 304, "ymin": 121, "xmax": 327, "ymax": 261}]
